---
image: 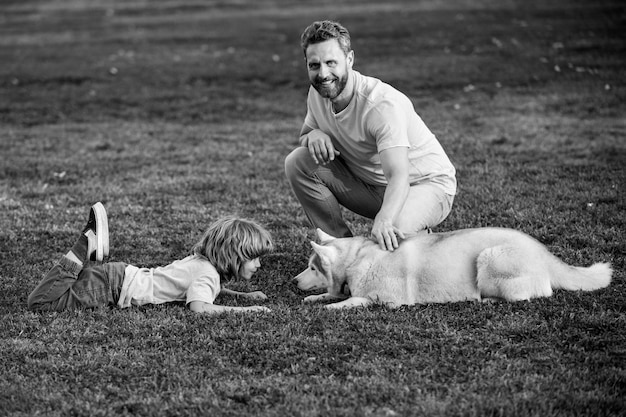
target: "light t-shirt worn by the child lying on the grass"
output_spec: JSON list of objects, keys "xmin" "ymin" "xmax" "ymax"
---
[{"xmin": 117, "ymin": 255, "xmax": 220, "ymax": 308}]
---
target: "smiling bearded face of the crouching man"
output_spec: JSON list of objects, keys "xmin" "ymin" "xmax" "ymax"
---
[{"xmin": 306, "ymin": 39, "xmax": 354, "ymax": 100}]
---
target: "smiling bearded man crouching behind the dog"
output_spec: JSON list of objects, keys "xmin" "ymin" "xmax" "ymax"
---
[{"xmin": 285, "ymin": 21, "xmax": 456, "ymax": 251}]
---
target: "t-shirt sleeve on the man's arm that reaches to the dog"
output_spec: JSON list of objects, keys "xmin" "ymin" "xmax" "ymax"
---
[{"xmin": 366, "ymin": 99, "xmax": 411, "ymax": 152}]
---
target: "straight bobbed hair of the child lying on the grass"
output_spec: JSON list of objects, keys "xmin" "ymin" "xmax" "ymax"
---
[{"xmin": 192, "ymin": 216, "xmax": 274, "ymax": 280}]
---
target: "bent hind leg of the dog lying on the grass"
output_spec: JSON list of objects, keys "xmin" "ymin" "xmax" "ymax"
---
[{"xmin": 476, "ymin": 245, "xmax": 552, "ymax": 301}]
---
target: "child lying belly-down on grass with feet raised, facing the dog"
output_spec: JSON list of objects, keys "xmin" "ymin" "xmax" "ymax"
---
[{"xmin": 28, "ymin": 202, "xmax": 273, "ymax": 313}]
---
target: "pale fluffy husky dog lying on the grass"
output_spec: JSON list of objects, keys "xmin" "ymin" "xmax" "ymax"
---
[{"xmin": 294, "ymin": 228, "xmax": 612, "ymax": 308}]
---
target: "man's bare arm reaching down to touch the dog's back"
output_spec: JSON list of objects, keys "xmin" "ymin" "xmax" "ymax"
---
[{"xmin": 371, "ymin": 146, "xmax": 410, "ymax": 251}]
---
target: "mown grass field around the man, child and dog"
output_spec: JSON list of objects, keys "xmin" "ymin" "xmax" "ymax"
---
[{"xmin": 0, "ymin": 0, "xmax": 626, "ymax": 416}]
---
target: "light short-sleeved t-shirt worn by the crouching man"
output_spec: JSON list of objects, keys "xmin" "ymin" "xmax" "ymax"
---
[{"xmin": 304, "ymin": 71, "xmax": 456, "ymax": 195}]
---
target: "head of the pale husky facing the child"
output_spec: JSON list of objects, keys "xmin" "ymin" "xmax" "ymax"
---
[{"xmin": 294, "ymin": 229, "xmax": 352, "ymax": 294}]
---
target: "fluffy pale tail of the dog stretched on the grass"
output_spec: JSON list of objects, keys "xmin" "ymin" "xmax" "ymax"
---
[{"xmin": 550, "ymin": 260, "xmax": 613, "ymax": 291}]
